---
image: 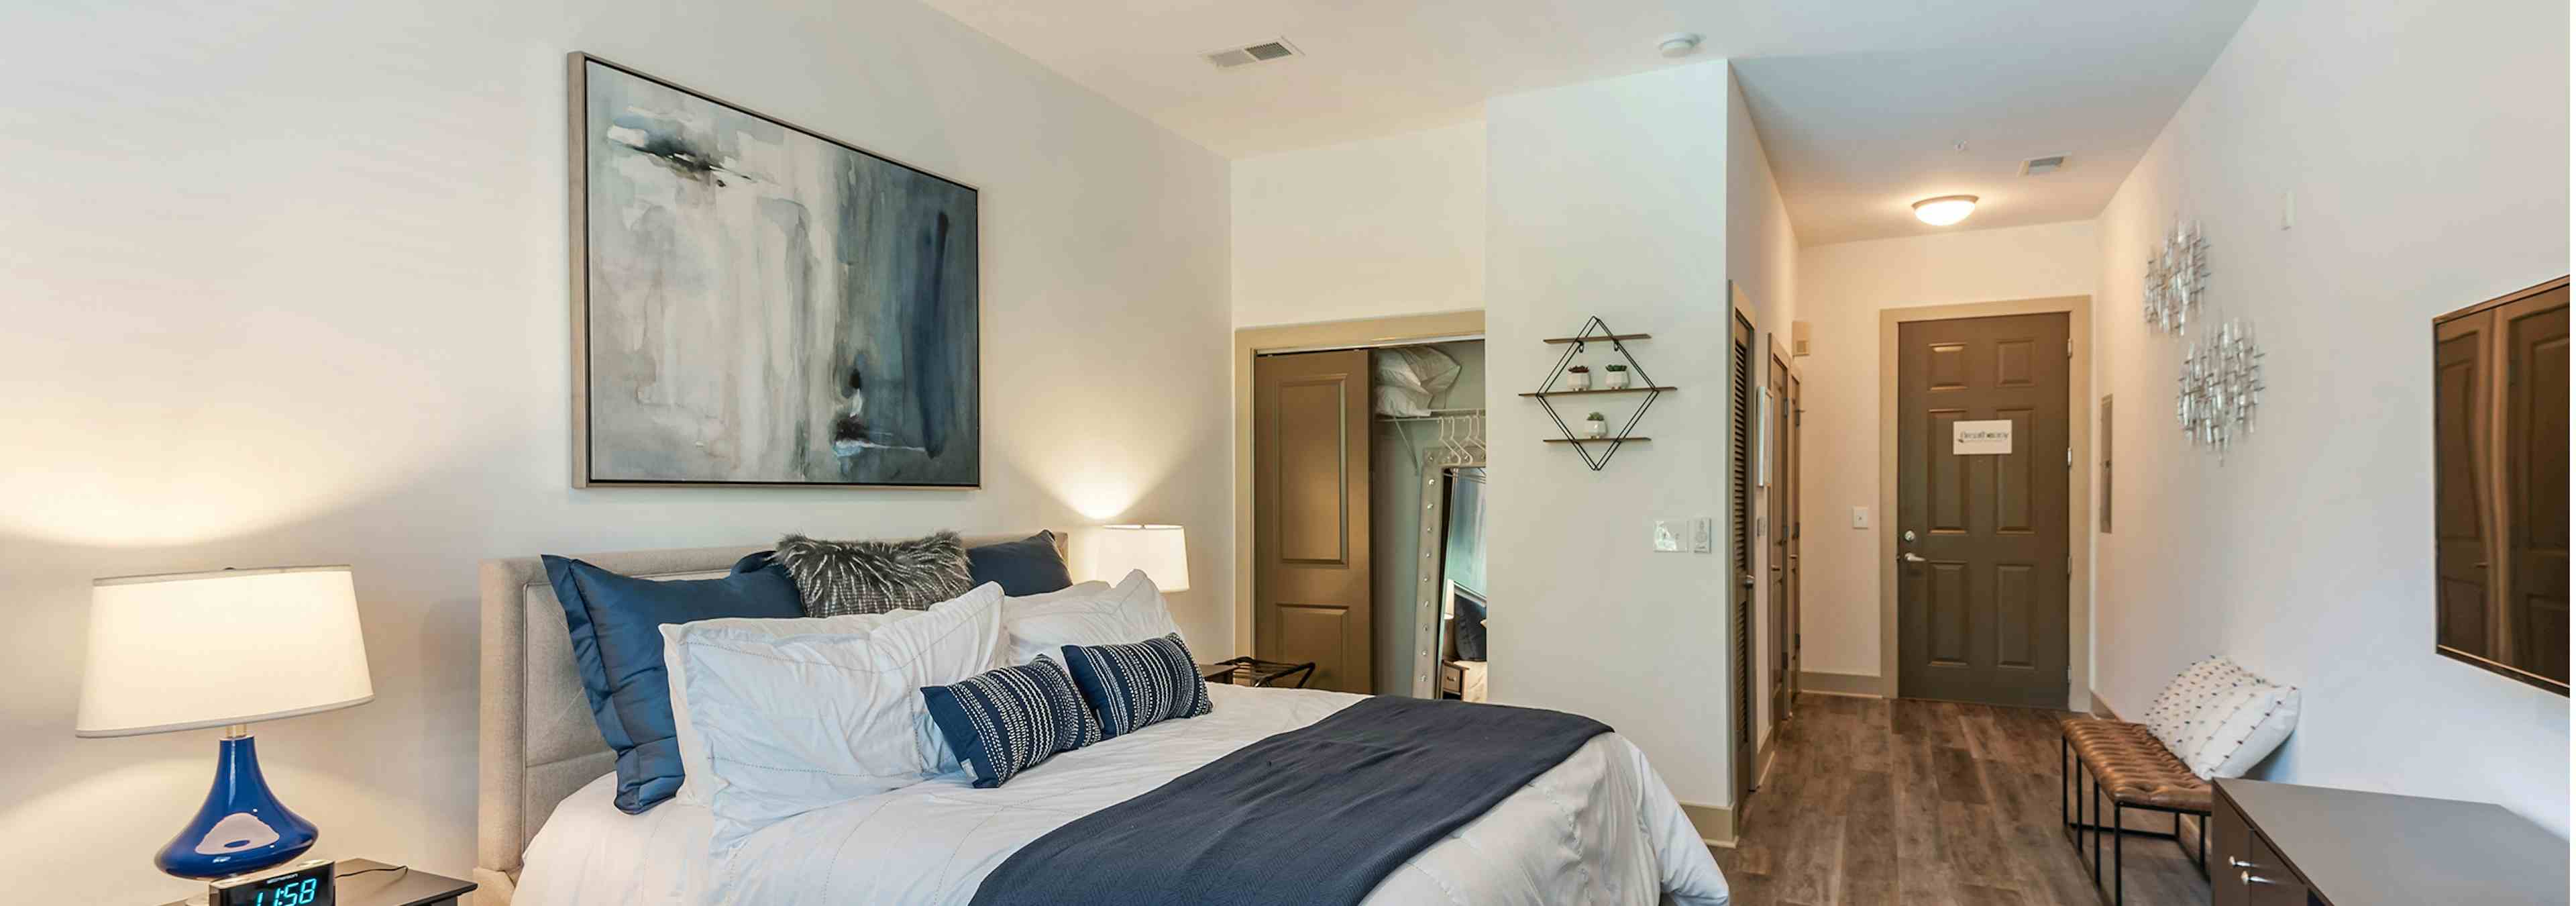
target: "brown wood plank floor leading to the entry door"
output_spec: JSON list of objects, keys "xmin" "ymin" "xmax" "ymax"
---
[{"xmin": 1711, "ymin": 695, "xmax": 2210, "ymax": 906}]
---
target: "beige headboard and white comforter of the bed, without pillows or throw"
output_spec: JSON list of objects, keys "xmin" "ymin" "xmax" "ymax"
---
[{"xmin": 474, "ymin": 533, "xmax": 1726, "ymax": 906}]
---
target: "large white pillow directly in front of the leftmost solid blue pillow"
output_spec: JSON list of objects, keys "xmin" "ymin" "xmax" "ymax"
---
[{"xmin": 665, "ymin": 585, "xmax": 1002, "ymax": 857}]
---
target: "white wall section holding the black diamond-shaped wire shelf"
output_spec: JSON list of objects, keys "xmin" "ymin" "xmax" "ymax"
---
[{"xmin": 1484, "ymin": 62, "xmax": 1729, "ymax": 805}]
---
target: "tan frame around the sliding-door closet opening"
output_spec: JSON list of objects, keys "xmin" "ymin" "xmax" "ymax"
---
[{"xmin": 1229, "ymin": 309, "xmax": 1484, "ymax": 656}]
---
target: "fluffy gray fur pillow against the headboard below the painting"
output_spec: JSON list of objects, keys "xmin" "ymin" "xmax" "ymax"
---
[{"xmin": 778, "ymin": 533, "xmax": 971, "ymax": 617}]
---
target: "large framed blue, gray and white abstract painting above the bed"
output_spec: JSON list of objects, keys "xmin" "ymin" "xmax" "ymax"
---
[{"xmin": 572, "ymin": 54, "xmax": 984, "ymax": 487}]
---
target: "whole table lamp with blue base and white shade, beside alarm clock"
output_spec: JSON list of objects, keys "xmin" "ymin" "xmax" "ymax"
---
[{"xmin": 72, "ymin": 566, "xmax": 376, "ymax": 880}]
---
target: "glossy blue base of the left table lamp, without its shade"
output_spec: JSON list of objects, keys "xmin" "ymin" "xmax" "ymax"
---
[{"xmin": 152, "ymin": 728, "xmax": 322, "ymax": 880}]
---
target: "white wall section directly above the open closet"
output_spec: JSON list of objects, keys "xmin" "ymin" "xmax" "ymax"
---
[{"xmin": 1234, "ymin": 121, "xmax": 1487, "ymax": 327}]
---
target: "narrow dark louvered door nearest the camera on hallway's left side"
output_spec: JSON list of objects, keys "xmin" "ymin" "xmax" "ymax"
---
[{"xmin": 1726, "ymin": 311, "xmax": 1757, "ymax": 808}]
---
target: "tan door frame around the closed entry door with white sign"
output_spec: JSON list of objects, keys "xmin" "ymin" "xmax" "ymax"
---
[{"xmin": 1878, "ymin": 296, "xmax": 2094, "ymax": 711}]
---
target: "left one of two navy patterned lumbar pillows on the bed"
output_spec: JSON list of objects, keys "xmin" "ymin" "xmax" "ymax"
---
[{"xmin": 922, "ymin": 656, "xmax": 1103, "ymax": 790}]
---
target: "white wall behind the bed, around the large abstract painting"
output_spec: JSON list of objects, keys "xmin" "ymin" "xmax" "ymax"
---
[{"xmin": 0, "ymin": 0, "xmax": 1232, "ymax": 903}]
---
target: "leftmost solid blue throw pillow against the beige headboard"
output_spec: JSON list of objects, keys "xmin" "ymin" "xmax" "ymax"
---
[{"xmin": 543, "ymin": 554, "xmax": 804, "ymax": 816}]
